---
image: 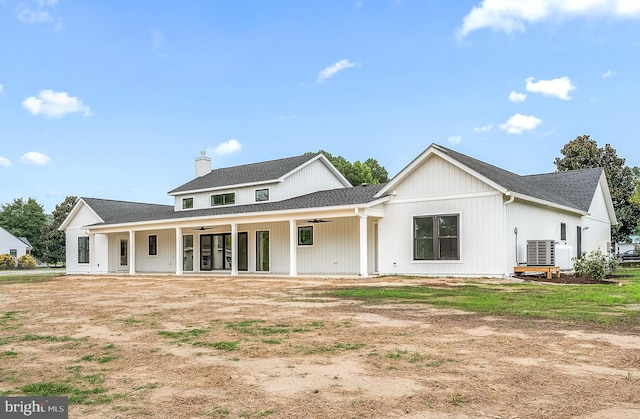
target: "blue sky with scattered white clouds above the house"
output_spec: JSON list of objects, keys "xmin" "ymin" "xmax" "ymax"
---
[{"xmin": 0, "ymin": 0, "xmax": 640, "ymax": 212}]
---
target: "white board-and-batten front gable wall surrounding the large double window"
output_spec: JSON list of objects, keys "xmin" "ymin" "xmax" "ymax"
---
[{"xmin": 378, "ymin": 156, "xmax": 505, "ymax": 277}]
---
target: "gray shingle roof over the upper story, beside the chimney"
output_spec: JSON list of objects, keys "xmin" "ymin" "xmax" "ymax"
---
[{"xmin": 169, "ymin": 153, "xmax": 318, "ymax": 194}]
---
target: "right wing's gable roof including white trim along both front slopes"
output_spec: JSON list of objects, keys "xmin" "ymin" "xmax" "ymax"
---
[{"xmin": 379, "ymin": 144, "xmax": 603, "ymax": 214}]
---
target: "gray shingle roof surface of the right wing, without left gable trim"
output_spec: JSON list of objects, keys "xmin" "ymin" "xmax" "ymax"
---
[{"xmin": 434, "ymin": 145, "xmax": 603, "ymax": 211}]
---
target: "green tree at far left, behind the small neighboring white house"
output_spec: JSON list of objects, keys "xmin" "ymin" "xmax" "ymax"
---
[{"xmin": 0, "ymin": 198, "xmax": 47, "ymax": 257}]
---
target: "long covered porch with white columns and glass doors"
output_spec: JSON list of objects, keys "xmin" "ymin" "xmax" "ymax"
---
[{"xmin": 89, "ymin": 207, "xmax": 382, "ymax": 277}]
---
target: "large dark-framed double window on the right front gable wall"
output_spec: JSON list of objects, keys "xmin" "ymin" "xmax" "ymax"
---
[{"xmin": 413, "ymin": 214, "xmax": 460, "ymax": 260}]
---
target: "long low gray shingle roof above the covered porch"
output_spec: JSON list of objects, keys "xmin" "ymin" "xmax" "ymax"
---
[{"xmin": 82, "ymin": 184, "xmax": 384, "ymax": 225}]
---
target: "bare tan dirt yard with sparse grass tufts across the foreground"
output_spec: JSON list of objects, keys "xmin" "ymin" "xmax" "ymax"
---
[{"xmin": 0, "ymin": 276, "xmax": 640, "ymax": 419}]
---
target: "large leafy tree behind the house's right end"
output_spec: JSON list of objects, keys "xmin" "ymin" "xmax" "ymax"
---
[{"xmin": 555, "ymin": 135, "xmax": 640, "ymax": 242}]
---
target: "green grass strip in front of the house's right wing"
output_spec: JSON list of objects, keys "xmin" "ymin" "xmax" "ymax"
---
[{"xmin": 330, "ymin": 268, "xmax": 640, "ymax": 325}]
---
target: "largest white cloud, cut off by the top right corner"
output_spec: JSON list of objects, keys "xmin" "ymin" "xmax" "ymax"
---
[{"xmin": 458, "ymin": 0, "xmax": 640, "ymax": 37}]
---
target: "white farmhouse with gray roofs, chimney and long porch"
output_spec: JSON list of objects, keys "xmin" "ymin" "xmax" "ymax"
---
[{"xmin": 60, "ymin": 144, "xmax": 616, "ymax": 277}]
